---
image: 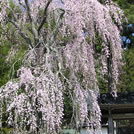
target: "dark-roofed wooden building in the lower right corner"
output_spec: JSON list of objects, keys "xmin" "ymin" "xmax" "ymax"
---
[{"xmin": 98, "ymin": 93, "xmax": 134, "ymax": 134}]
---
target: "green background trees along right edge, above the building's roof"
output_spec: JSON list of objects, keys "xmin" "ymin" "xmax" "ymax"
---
[{"xmin": 112, "ymin": 0, "xmax": 134, "ymax": 92}]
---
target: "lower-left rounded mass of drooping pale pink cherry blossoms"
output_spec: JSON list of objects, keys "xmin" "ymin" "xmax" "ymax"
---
[{"xmin": 0, "ymin": 67, "xmax": 63, "ymax": 134}]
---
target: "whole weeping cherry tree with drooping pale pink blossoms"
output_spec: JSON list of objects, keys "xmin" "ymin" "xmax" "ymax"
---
[{"xmin": 0, "ymin": 0, "xmax": 124, "ymax": 134}]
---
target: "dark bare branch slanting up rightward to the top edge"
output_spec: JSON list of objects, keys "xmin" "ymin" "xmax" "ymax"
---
[{"xmin": 38, "ymin": 0, "xmax": 52, "ymax": 34}]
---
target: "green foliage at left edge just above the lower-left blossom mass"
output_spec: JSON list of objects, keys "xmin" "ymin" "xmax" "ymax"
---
[{"xmin": 0, "ymin": 42, "xmax": 26, "ymax": 86}]
